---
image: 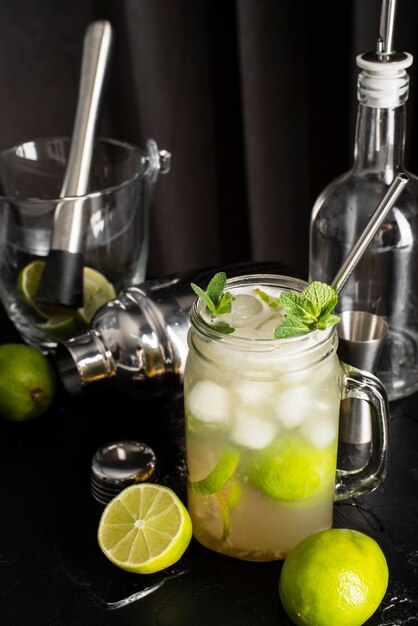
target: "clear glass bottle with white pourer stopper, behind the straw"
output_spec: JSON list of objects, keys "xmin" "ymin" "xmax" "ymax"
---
[{"xmin": 310, "ymin": 31, "xmax": 418, "ymax": 400}]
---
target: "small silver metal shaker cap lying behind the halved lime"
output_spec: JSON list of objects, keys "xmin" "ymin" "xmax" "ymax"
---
[{"xmin": 90, "ymin": 439, "xmax": 157, "ymax": 504}]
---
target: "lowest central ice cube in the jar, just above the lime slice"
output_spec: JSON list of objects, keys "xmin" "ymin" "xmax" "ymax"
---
[{"xmin": 231, "ymin": 407, "xmax": 277, "ymax": 450}]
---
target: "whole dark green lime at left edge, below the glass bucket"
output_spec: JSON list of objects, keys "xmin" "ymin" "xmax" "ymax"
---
[{"xmin": 0, "ymin": 343, "xmax": 56, "ymax": 422}]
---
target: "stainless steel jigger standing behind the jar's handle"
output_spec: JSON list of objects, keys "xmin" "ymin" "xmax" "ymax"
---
[{"xmin": 338, "ymin": 311, "xmax": 388, "ymax": 450}]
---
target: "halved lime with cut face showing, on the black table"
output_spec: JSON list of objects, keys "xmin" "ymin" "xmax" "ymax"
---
[{"xmin": 97, "ymin": 483, "xmax": 192, "ymax": 574}]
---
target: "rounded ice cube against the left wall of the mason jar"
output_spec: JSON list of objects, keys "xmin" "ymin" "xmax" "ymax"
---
[{"xmin": 187, "ymin": 380, "xmax": 232, "ymax": 423}]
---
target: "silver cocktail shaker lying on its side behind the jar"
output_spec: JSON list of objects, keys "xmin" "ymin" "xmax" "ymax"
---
[{"xmin": 55, "ymin": 262, "xmax": 292, "ymax": 400}]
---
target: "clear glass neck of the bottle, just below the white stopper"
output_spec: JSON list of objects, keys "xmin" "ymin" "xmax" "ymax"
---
[{"xmin": 354, "ymin": 103, "xmax": 406, "ymax": 179}]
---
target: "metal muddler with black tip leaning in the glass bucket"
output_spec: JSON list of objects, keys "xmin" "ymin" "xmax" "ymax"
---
[{"xmin": 36, "ymin": 20, "xmax": 112, "ymax": 308}]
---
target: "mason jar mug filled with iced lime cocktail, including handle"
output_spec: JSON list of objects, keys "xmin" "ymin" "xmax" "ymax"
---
[{"xmin": 184, "ymin": 275, "xmax": 387, "ymax": 561}]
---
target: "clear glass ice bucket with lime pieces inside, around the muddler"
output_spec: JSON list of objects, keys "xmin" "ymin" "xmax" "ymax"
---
[{"xmin": 0, "ymin": 138, "xmax": 170, "ymax": 350}]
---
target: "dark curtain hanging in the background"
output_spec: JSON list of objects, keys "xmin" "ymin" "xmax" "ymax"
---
[{"xmin": 0, "ymin": 0, "xmax": 418, "ymax": 277}]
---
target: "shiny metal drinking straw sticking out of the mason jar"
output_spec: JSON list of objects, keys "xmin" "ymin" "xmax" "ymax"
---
[{"xmin": 331, "ymin": 174, "xmax": 409, "ymax": 294}]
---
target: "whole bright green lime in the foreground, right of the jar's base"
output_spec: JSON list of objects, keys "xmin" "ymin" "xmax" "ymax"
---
[{"xmin": 279, "ymin": 528, "xmax": 389, "ymax": 626}]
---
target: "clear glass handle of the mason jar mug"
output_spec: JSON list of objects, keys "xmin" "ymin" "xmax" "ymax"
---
[{"xmin": 335, "ymin": 363, "xmax": 389, "ymax": 500}]
